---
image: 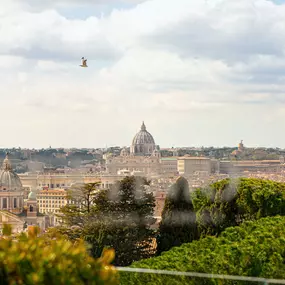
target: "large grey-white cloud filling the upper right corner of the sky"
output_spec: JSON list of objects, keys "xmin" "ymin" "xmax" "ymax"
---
[{"xmin": 142, "ymin": 0, "xmax": 285, "ymax": 63}]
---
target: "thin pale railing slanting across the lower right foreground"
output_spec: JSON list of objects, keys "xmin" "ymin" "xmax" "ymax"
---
[{"xmin": 116, "ymin": 267, "xmax": 285, "ymax": 285}]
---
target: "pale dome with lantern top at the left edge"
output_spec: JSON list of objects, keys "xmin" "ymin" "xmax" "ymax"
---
[{"xmin": 0, "ymin": 155, "xmax": 23, "ymax": 191}]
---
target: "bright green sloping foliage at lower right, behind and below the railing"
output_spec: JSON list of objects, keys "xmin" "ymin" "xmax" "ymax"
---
[{"xmin": 120, "ymin": 216, "xmax": 285, "ymax": 285}]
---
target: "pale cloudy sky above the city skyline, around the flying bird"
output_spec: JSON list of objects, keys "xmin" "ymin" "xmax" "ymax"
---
[{"xmin": 0, "ymin": 0, "xmax": 285, "ymax": 148}]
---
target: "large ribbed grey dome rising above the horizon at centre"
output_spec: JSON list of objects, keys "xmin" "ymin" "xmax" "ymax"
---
[{"xmin": 131, "ymin": 122, "xmax": 155, "ymax": 155}]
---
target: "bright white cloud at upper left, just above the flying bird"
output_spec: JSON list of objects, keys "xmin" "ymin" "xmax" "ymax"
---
[{"xmin": 0, "ymin": 10, "xmax": 120, "ymax": 61}]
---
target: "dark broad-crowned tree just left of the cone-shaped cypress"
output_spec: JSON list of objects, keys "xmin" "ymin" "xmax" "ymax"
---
[{"xmin": 57, "ymin": 176, "xmax": 155, "ymax": 266}]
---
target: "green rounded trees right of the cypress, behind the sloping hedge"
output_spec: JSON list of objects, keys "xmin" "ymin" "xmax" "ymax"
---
[{"xmin": 192, "ymin": 178, "xmax": 285, "ymax": 236}]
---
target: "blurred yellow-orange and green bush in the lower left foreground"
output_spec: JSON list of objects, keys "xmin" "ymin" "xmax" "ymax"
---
[{"xmin": 0, "ymin": 226, "xmax": 118, "ymax": 285}]
